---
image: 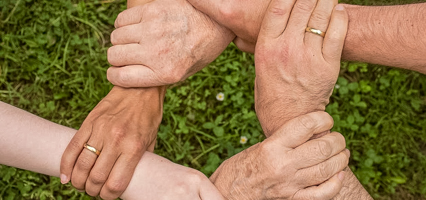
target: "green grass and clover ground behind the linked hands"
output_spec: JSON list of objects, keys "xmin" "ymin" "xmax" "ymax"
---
[{"xmin": 0, "ymin": 0, "xmax": 426, "ymax": 199}]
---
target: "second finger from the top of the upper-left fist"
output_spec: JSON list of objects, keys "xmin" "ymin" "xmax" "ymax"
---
[{"xmin": 111, "ymin": 23, "xmax": 144, "ymax": 45}]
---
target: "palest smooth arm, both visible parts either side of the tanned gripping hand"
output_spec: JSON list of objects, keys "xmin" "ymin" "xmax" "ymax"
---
[{"xmin": 0, "ymin": 102, "xmax": 222, "ymax": 199}]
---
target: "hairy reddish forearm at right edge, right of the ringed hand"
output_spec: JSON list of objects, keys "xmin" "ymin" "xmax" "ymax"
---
[{"xmin": 343, "ymin": 3, "xmax": 426, "ymax": 73}]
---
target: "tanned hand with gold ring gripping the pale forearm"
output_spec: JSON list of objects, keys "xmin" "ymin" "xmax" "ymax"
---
[{"xmin": 61, "ymin": 87, "xmax": 165, "ymax": 199}]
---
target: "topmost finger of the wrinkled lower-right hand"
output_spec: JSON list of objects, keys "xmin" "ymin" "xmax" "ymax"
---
[{"xmin": 268, "ymin": 112, "xmax": 333, "ymax": 148}]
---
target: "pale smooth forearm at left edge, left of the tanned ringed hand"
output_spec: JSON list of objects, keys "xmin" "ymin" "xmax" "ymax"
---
[{"xmin": 0, "ymin": 102, "xmax": 75, "ymax": 177}]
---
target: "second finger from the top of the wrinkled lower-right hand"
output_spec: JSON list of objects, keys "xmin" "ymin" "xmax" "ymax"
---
[{"xmin": 289, "ymin": 132, "xmax": 346, "ymax": 169}]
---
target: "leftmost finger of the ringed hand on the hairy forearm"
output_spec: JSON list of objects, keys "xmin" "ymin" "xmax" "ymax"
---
[{"xmin": 259, "ymin": 0, "xmax": 300, "ymax": 38}]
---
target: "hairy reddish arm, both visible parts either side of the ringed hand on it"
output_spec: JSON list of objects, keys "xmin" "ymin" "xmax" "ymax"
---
[{"xmin": 189, "ymin": 0, "xmax": 426, "ymax": 73}]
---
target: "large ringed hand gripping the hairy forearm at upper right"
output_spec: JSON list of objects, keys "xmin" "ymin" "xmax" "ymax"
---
[{"xmin": 255, "ymin": 0, "xmax": 348, "ymax": 135}]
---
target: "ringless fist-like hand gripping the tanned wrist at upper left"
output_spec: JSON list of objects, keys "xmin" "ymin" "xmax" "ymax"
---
[{"xmin": 107, "ymin": 0, "xmax": 233, "ymax": 87}]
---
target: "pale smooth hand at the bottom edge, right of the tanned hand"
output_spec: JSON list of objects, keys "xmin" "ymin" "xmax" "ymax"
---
[{"xmin": 121, "ymin": 152, "xmax": 223, "ymax": 200}]
